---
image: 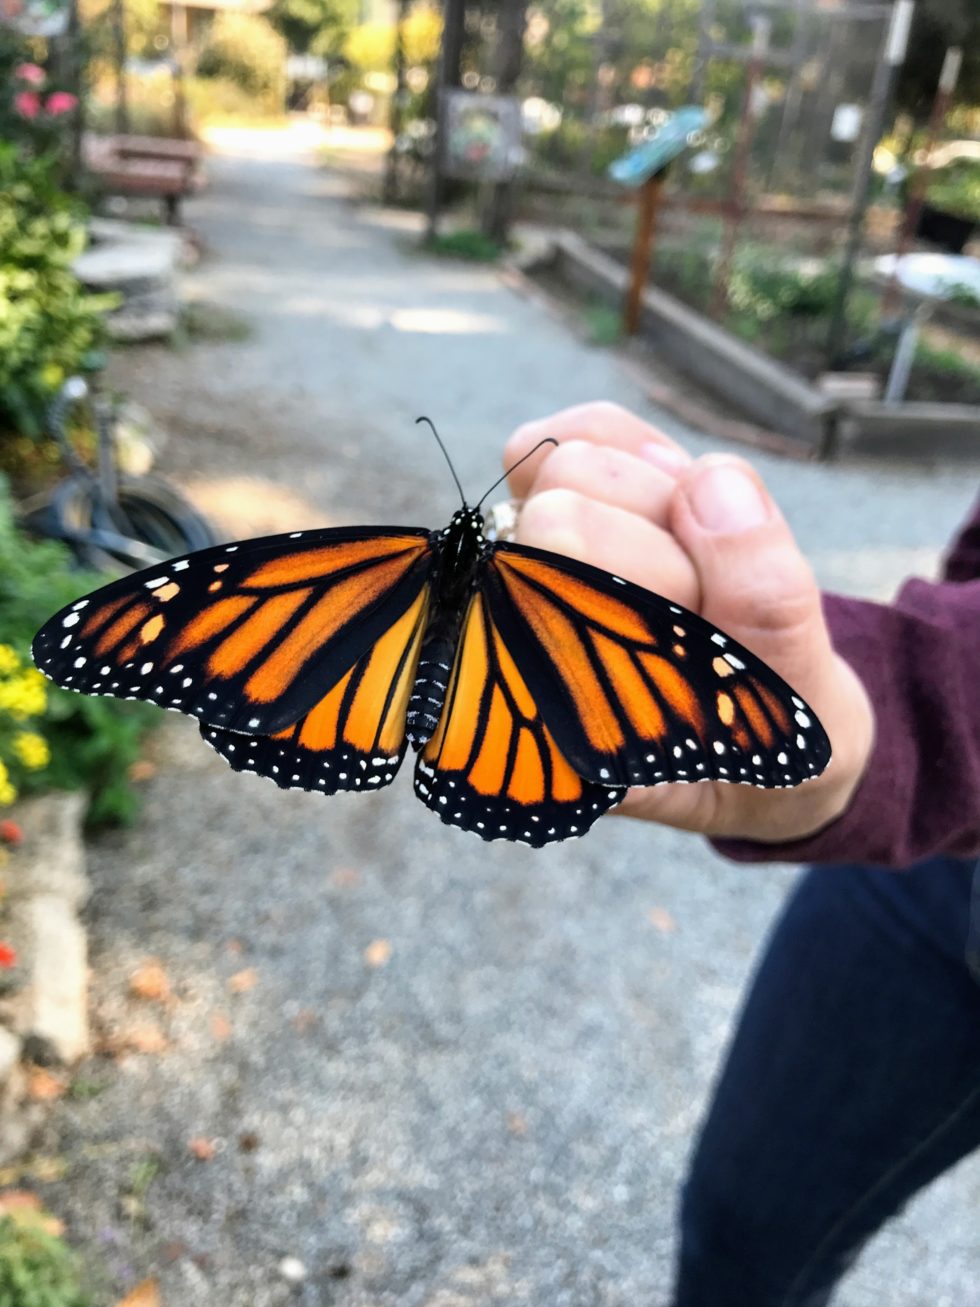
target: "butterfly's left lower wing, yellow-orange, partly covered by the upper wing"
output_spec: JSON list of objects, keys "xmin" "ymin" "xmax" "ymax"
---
[{"xmin": 201, "ymin": 588, "xmax": 429, "ymax": 795}]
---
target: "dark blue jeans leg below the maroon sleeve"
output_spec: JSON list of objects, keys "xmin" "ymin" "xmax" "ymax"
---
[{"xmin": 673, "ymin": 859, "xmax": 980, "ymax": 1307}]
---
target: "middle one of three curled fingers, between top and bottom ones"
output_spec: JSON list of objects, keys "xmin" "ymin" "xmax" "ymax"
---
[{"xmin": 527, "ymin": 440, "xmax": 677, "ymax": 527}]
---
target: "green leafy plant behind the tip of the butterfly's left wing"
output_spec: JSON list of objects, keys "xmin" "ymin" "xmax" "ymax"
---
[{"xmin": 0, "ymin": 482, "xmax": 157, "ymax": 826}]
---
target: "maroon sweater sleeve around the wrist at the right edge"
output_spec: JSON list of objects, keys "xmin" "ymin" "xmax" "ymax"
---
[{"xmin": 713, "ymin": 501, "xmax": 980, "ymax": 868}]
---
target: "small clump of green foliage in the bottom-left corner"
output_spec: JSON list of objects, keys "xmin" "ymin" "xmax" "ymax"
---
[{"xmin": 0, "ymin": 1213, "xmax": 91, "ymax": 1307}]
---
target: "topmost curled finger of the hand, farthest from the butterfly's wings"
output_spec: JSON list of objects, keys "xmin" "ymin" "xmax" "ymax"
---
[{"xmin": 504, "ymin": 400, "xmax": 691, "ymax": 499}]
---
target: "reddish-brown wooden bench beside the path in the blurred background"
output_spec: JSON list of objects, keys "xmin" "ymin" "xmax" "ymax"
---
[{"xmin": 85, "ymin": 136, "xmax": 204, "ymax": 226}]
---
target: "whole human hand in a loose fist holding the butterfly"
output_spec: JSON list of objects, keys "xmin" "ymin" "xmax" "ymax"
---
[{"xmin": 504, "ymin": 403, "xmax": 874, "ymax": 843}]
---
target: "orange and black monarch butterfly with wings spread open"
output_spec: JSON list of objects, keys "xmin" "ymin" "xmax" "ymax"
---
[{"xmin": 34, "ymin": 418, "xmax": 830, "ymax": 847}]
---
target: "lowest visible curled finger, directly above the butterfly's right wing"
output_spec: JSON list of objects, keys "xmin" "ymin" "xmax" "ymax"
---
[{"xmin": 517, "ymin": 489, "xmax": 700, "ymax": 609}]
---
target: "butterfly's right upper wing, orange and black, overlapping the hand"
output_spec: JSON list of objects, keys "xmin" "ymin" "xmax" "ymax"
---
[{"xmin": 483, "ymin": 544, "xmax": 830, "ymax": 789}]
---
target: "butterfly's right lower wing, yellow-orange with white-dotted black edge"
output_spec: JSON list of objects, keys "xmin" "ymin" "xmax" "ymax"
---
[{"xmin": 416, "ymin": 592, "xmax": 626, "ymax": 847}]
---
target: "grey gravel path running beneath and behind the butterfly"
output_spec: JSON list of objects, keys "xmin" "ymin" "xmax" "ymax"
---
[{"xmin": 38, "ymin": 124, "xmax": 980, "ymax": 1307}]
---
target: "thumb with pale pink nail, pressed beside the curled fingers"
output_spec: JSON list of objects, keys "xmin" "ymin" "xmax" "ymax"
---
[{"xmin": 670, "ymin": 455, "xmax": 832, "ymax": 698}]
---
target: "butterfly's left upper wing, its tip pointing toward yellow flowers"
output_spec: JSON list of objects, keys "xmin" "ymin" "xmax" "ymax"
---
[{"xmin": 34, "ymin": 527, "xmax": 434, "ymax": 735}]
